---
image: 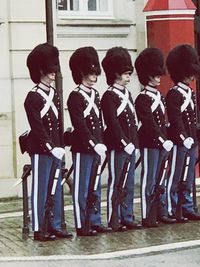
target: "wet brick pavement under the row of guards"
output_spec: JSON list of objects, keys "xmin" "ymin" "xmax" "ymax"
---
[{"xmin": 0, "ymin": 189, "xmax": 200, "ymax": 261}]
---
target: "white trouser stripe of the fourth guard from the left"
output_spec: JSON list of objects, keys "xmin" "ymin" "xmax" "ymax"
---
[{"xmin": 142, "ymin": 148, "xmax": 148, "ymax": 219}]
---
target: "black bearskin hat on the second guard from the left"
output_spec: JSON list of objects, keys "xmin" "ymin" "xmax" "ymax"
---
[{"xmin": 69, "ymin": 46, "xmax": 101, "ymax": 84}]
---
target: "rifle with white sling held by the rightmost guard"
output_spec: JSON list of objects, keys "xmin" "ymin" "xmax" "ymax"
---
[{"xmin": 175, "ymin": 155, "xmax": 190, "ymax": 222}]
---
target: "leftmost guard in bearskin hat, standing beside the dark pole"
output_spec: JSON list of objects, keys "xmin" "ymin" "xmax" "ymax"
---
[{"xmin": 24, "ymin": 43, "xmax": 72, "ymax": 241}]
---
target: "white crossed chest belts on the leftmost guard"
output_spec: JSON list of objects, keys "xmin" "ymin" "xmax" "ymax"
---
[{"xmin": 37, "ymin": 88, "xmax": 58, "ymax": 118}]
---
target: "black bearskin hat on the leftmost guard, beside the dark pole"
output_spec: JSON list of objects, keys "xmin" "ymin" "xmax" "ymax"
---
[{"xmin": 26, "ymin": 43, "xmax": 60, "ymax": 83}]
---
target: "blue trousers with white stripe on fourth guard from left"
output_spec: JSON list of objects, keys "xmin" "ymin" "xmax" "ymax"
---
[{"xmin": 141, "ymin": 148, "xmax": 169, "ymax": 219}]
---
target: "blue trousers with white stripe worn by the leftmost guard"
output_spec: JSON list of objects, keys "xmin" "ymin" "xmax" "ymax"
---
[{"xmin": 31, "ymin": 154, "xmax": 62, "ymax": 231}]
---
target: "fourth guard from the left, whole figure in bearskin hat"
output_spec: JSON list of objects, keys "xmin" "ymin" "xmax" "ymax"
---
[{"xmin": 135, "ymin": 48, "xmax": 176, "ymax": 227}]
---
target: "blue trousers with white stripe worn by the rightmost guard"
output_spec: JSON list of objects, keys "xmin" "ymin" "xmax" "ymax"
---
[{"xmin": 167, "ymin": 146, "xmax": 196, "ymax": 215}]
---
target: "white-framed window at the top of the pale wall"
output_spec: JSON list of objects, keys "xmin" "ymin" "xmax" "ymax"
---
[{"xmin": 57, "ymin": 0, "xmax": 112, "ymax": 18}]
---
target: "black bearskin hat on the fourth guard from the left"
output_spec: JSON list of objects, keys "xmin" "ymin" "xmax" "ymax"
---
[{"xmin": 135, "ymin": 48, "xmax": 165, "ymax": 86}]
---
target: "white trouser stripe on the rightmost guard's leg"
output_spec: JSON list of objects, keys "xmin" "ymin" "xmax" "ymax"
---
[{"xmin": 167, "ymin": 145, "xmax": 177, "ymax": 215}]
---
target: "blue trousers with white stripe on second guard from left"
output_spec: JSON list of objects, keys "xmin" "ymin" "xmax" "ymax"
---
[{"xmin": 72, "ymin": 153, "xmax": 101, "ymax": 229}]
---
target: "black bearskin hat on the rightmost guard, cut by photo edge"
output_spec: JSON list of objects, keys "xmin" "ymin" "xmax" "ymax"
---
[{"xmin": 166, "ymin": 44, "xmax": 200, "ymax": 83}]
